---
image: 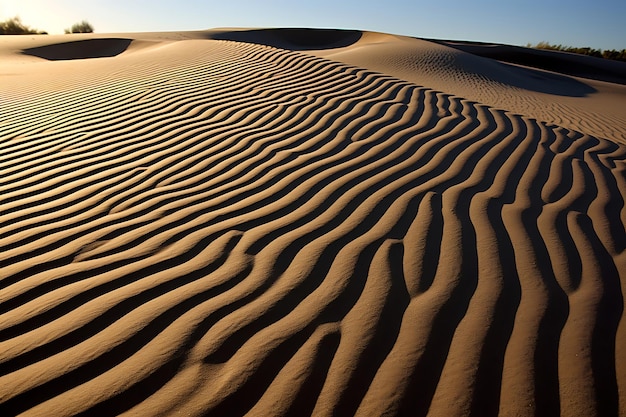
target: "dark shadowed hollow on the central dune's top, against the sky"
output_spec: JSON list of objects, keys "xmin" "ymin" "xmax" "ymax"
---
[{"xmin": 211, "ymin": 28, "xmax": 363, "ymax": 51}]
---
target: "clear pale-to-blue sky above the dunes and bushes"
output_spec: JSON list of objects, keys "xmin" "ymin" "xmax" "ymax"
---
[{"xmin": 0, "ymin": 0, "xmax": 626, "ymax": 49}]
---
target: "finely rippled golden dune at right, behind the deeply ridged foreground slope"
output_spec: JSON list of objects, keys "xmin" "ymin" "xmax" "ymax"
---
[{"xmin": 312, "ymin": 33, "xmax": 626, "ymax": 144}]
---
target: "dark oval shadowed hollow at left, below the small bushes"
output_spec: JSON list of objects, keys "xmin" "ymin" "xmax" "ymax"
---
[{"xmin": 22, "ymin": 38, "xmax": 132, "ymax": 61}]
